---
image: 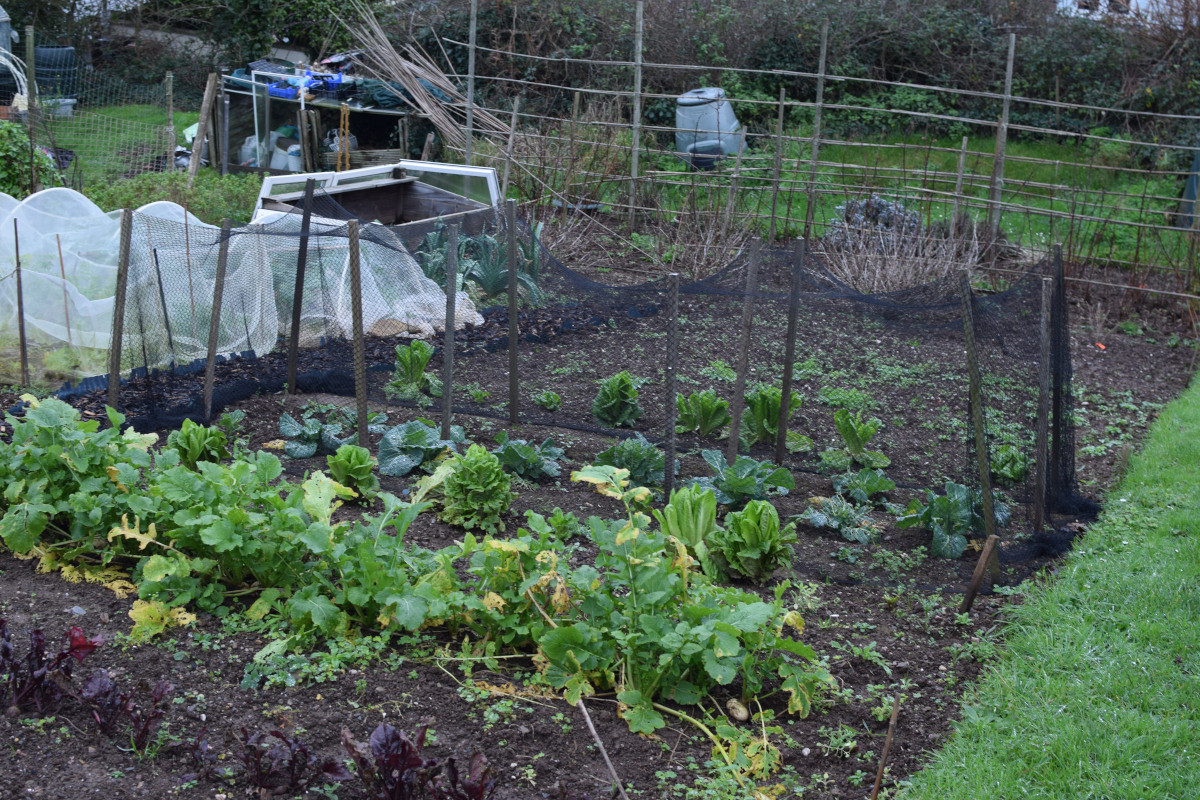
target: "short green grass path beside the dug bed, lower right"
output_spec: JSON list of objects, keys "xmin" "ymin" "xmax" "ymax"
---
[{"xmin": 901, "ymin": 380, "xmax": 1200, "ymax": 800}]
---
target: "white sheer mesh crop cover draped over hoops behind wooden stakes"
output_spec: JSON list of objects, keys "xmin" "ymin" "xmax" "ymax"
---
[{"xmin": 0, "ymin": 188, "xmax": 482, "ymax": 385}]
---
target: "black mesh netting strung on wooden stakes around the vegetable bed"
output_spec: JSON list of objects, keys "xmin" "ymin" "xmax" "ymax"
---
[{"xmin": 46, "ymin": 193, "xmax": 1096, "ymax": 559}]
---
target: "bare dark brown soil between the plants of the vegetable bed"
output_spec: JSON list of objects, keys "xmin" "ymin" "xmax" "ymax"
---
[{"xmin": 0, "ymin": 261, "xmax": 1194, "ymax": 800}]
